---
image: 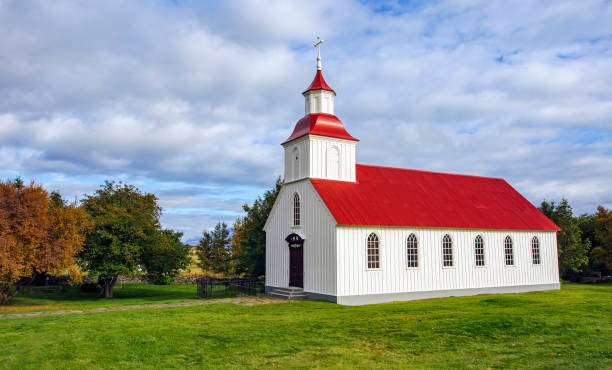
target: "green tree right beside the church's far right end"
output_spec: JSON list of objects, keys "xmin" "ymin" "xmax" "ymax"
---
[{"xmin": 540, "ymin": 199, "xmax": 591, "ymax": 279}]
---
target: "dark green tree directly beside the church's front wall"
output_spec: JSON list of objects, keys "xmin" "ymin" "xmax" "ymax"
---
[{"xmin": 232, "ymin": 177, "xmax": 283, "ymax": 276}]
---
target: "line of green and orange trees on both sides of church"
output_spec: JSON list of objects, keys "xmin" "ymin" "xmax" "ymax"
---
[{"xmin": 0, "ymin": 178, "xmax": 612, "ymax": 303}]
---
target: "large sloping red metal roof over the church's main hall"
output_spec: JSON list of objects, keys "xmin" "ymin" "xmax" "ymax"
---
[{"xmin": 310, "ymin": 164, "xmax": 560, "ymax": 231}]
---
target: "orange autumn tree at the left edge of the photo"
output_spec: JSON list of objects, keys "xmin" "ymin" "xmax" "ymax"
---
[{"xmin": 0, "ymin": 179, "xmax": 91, "ymax": 303}]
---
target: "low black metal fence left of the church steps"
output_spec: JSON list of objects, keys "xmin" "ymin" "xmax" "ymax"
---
[{"xmin": 196, "ymin": 277, "xmax": 264, "ymax": 298}]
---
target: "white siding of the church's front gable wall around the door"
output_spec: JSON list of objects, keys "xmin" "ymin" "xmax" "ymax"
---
[{"xmin": 265, "ymin": 180, "xmax": 336, "ymax": 295}]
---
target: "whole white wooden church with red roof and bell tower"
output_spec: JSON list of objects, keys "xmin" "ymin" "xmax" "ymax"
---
[{"xmin": 264, "ymin": 45, "xmax": 559, "ymax": 305}]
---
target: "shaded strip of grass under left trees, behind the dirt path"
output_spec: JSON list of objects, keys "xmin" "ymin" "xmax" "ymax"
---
[{"xmin": 0, "ymin": 284, "xmax": 197, "ymax": 316}]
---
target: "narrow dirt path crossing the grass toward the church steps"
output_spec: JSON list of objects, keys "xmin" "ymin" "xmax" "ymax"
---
[{"xmin": 0, "ymin": 296, "xmax": 287, "ymax": 319}]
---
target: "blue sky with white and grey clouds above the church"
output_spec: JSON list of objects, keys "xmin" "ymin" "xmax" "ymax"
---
[{"xmin": 0, "ymin": 0, "xmax": 612, "ymax": 240}]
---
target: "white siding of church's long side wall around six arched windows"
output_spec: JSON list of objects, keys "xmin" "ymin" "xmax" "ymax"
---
[{"xmin": 337, "ymin": 226, "xmax": 559, "ymax": 296}]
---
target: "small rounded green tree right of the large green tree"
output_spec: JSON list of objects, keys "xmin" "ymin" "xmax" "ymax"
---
[{"xmin": 141, "ymin": 230, "xmax": 191, "ymax": 284}]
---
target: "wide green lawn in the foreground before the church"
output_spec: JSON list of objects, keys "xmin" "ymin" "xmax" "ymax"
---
[{"xmin": 0, "ymin": 284, "xmax": 612, "ymax": 368}]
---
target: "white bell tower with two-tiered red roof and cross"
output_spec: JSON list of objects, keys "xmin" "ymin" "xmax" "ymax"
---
[{"xmin": 282, "ymin": 37, "xmax": 359, "ymax": 183}]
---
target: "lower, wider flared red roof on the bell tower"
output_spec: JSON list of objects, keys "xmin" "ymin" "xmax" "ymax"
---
[{"xmin": 283, "ymin": 113, "xmax": 359, "ymax": 144}]
